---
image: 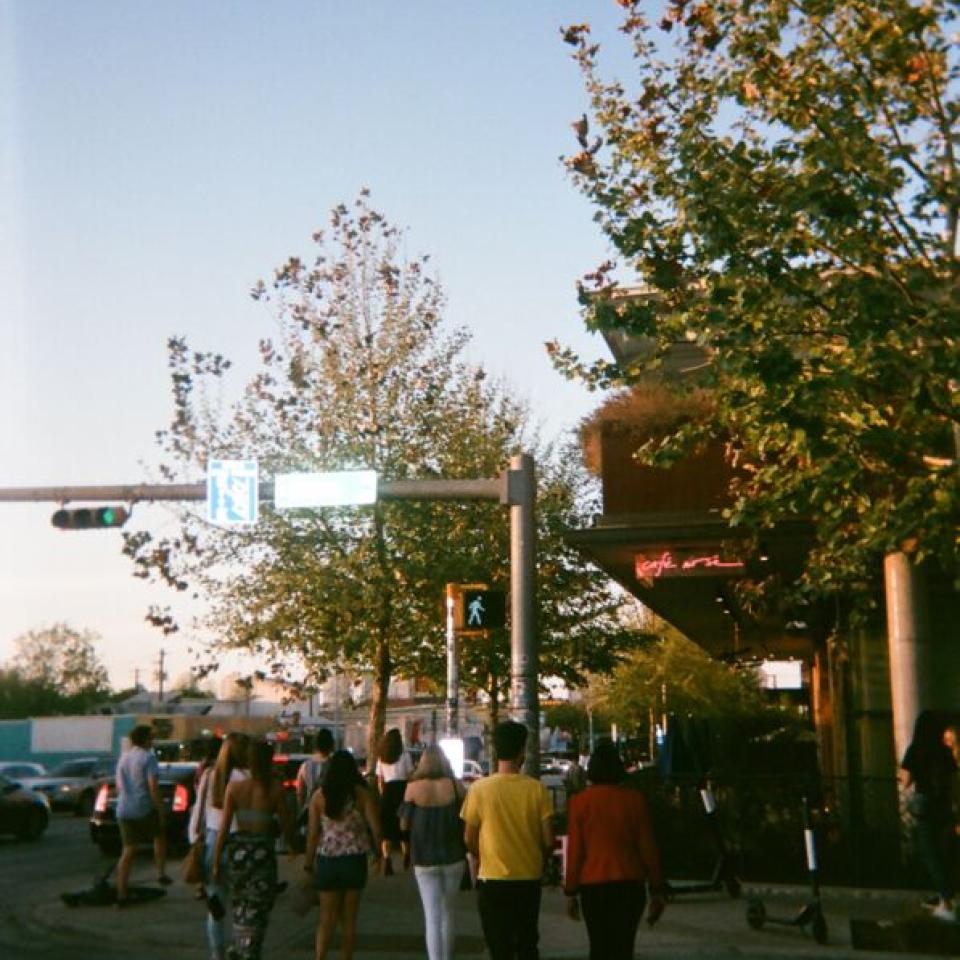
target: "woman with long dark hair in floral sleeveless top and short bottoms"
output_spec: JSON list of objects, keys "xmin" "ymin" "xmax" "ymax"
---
[{"xmin": 304, "ymin": 750, "xmax": 380, "ymax": 960}]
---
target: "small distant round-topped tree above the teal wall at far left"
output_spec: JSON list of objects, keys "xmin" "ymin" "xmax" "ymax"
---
[{"xmin": 14, "ymin": 623, "xmax": 110, "ymax": 703}]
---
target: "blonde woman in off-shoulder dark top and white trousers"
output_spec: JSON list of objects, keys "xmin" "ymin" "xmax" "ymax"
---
[{"xmin": 401, "ymin": 745, "xmax": 467, "ymax": 960}]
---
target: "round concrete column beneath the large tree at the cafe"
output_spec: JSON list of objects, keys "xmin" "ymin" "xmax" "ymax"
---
[{"xmin": 883, "ymin": 553, "xmax": 937, "ymax": 764}]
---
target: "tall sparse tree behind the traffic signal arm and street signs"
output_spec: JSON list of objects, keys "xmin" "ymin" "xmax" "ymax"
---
[{"xmin": 125, "ymin": 193, "xmax": 622, "ymax": 755}]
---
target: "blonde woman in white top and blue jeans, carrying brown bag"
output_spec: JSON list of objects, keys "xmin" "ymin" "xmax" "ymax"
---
[{"xmin": 188, "ymin": 733, "xmax": 249, "ymax": 960}]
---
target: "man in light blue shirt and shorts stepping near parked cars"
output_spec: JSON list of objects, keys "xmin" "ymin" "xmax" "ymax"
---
[{"xmin": 116, "ymin": 724, "xmax": 173, "ymax": 906}]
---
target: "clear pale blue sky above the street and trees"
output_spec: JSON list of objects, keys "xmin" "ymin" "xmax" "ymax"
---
[{"xmin": 0, "ymin": 0, "xmax": 629, "ymax": 687}]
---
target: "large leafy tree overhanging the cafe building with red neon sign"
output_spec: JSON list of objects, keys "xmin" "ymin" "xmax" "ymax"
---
[{"xmin": 551, "ymin": 0, "xmax": 960, "ymax": 616}]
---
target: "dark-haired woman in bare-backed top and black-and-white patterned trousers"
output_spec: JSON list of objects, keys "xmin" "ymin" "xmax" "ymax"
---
[{"xmin": 213, "ymin": 740, "xmax": 295, "ymax": 960}]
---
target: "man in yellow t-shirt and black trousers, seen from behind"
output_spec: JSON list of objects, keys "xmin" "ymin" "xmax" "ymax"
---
[{"xmin": 460, "ymin": 720, "xmax": 553, "ymax": 960}]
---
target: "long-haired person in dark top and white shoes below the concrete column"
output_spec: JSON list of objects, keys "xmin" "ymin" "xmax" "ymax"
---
[{"xmin": 900, "ymin": 710, "xmax": 957, "ymax": 920}]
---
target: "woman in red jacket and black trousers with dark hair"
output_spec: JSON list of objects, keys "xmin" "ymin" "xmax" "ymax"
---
[{"xmin": 564, "ymin": 740, "xmax": 665, "ymax": 960}]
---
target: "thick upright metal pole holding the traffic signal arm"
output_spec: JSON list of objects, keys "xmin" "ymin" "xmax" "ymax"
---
[{"xmin": 506, "ymin": 453, "xmax": 540, "ymax": 777}]
